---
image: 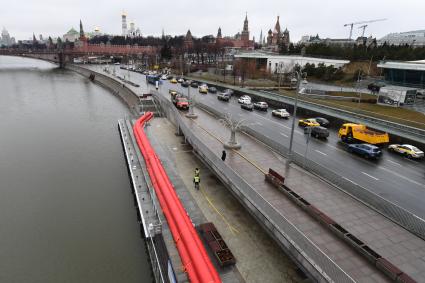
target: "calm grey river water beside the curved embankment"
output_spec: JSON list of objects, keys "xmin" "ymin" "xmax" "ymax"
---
[{"xmin": 0, "ymin": 56, "xmax": 152, "ymax": 283}]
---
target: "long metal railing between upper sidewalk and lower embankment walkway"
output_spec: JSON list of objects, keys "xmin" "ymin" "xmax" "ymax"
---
[{"xmin": 155, "ymin": 94, "xmax": 354, "ymax": 282}]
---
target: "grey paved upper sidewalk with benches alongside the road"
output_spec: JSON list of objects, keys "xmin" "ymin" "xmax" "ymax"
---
[{"xmin": 187, "ymin": 109, "xmax": 425, "ymax": 282}]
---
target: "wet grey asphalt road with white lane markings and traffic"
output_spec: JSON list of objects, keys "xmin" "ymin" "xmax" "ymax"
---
[{"xmin": 91, "ymin": 66, "xmax": 425, "ymax": 219}]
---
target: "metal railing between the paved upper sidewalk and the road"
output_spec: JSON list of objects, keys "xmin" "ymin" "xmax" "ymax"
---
[{"xmin": 194, "ymin": 103, "xmax": 425, "ymax": 240}]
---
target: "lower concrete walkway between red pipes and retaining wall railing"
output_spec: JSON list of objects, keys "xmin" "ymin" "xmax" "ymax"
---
[{"xmin": 146, "ymin": 118, "xmax": 303, "ymax": 282}]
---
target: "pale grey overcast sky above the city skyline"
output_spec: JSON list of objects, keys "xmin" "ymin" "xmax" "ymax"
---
[{"xmin": 0, "ymin": 0, "xmax": 425, "ymax": 41}]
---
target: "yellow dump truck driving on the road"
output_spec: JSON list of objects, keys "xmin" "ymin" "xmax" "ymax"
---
[{"xmin": 338, "ymin": 123, "xmax": 390, "ymax": 145}]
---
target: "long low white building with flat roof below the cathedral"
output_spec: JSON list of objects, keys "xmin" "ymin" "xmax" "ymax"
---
[{"xmin": 235, "ymin": 52, "xmax": 350, "ymax": 73}]
